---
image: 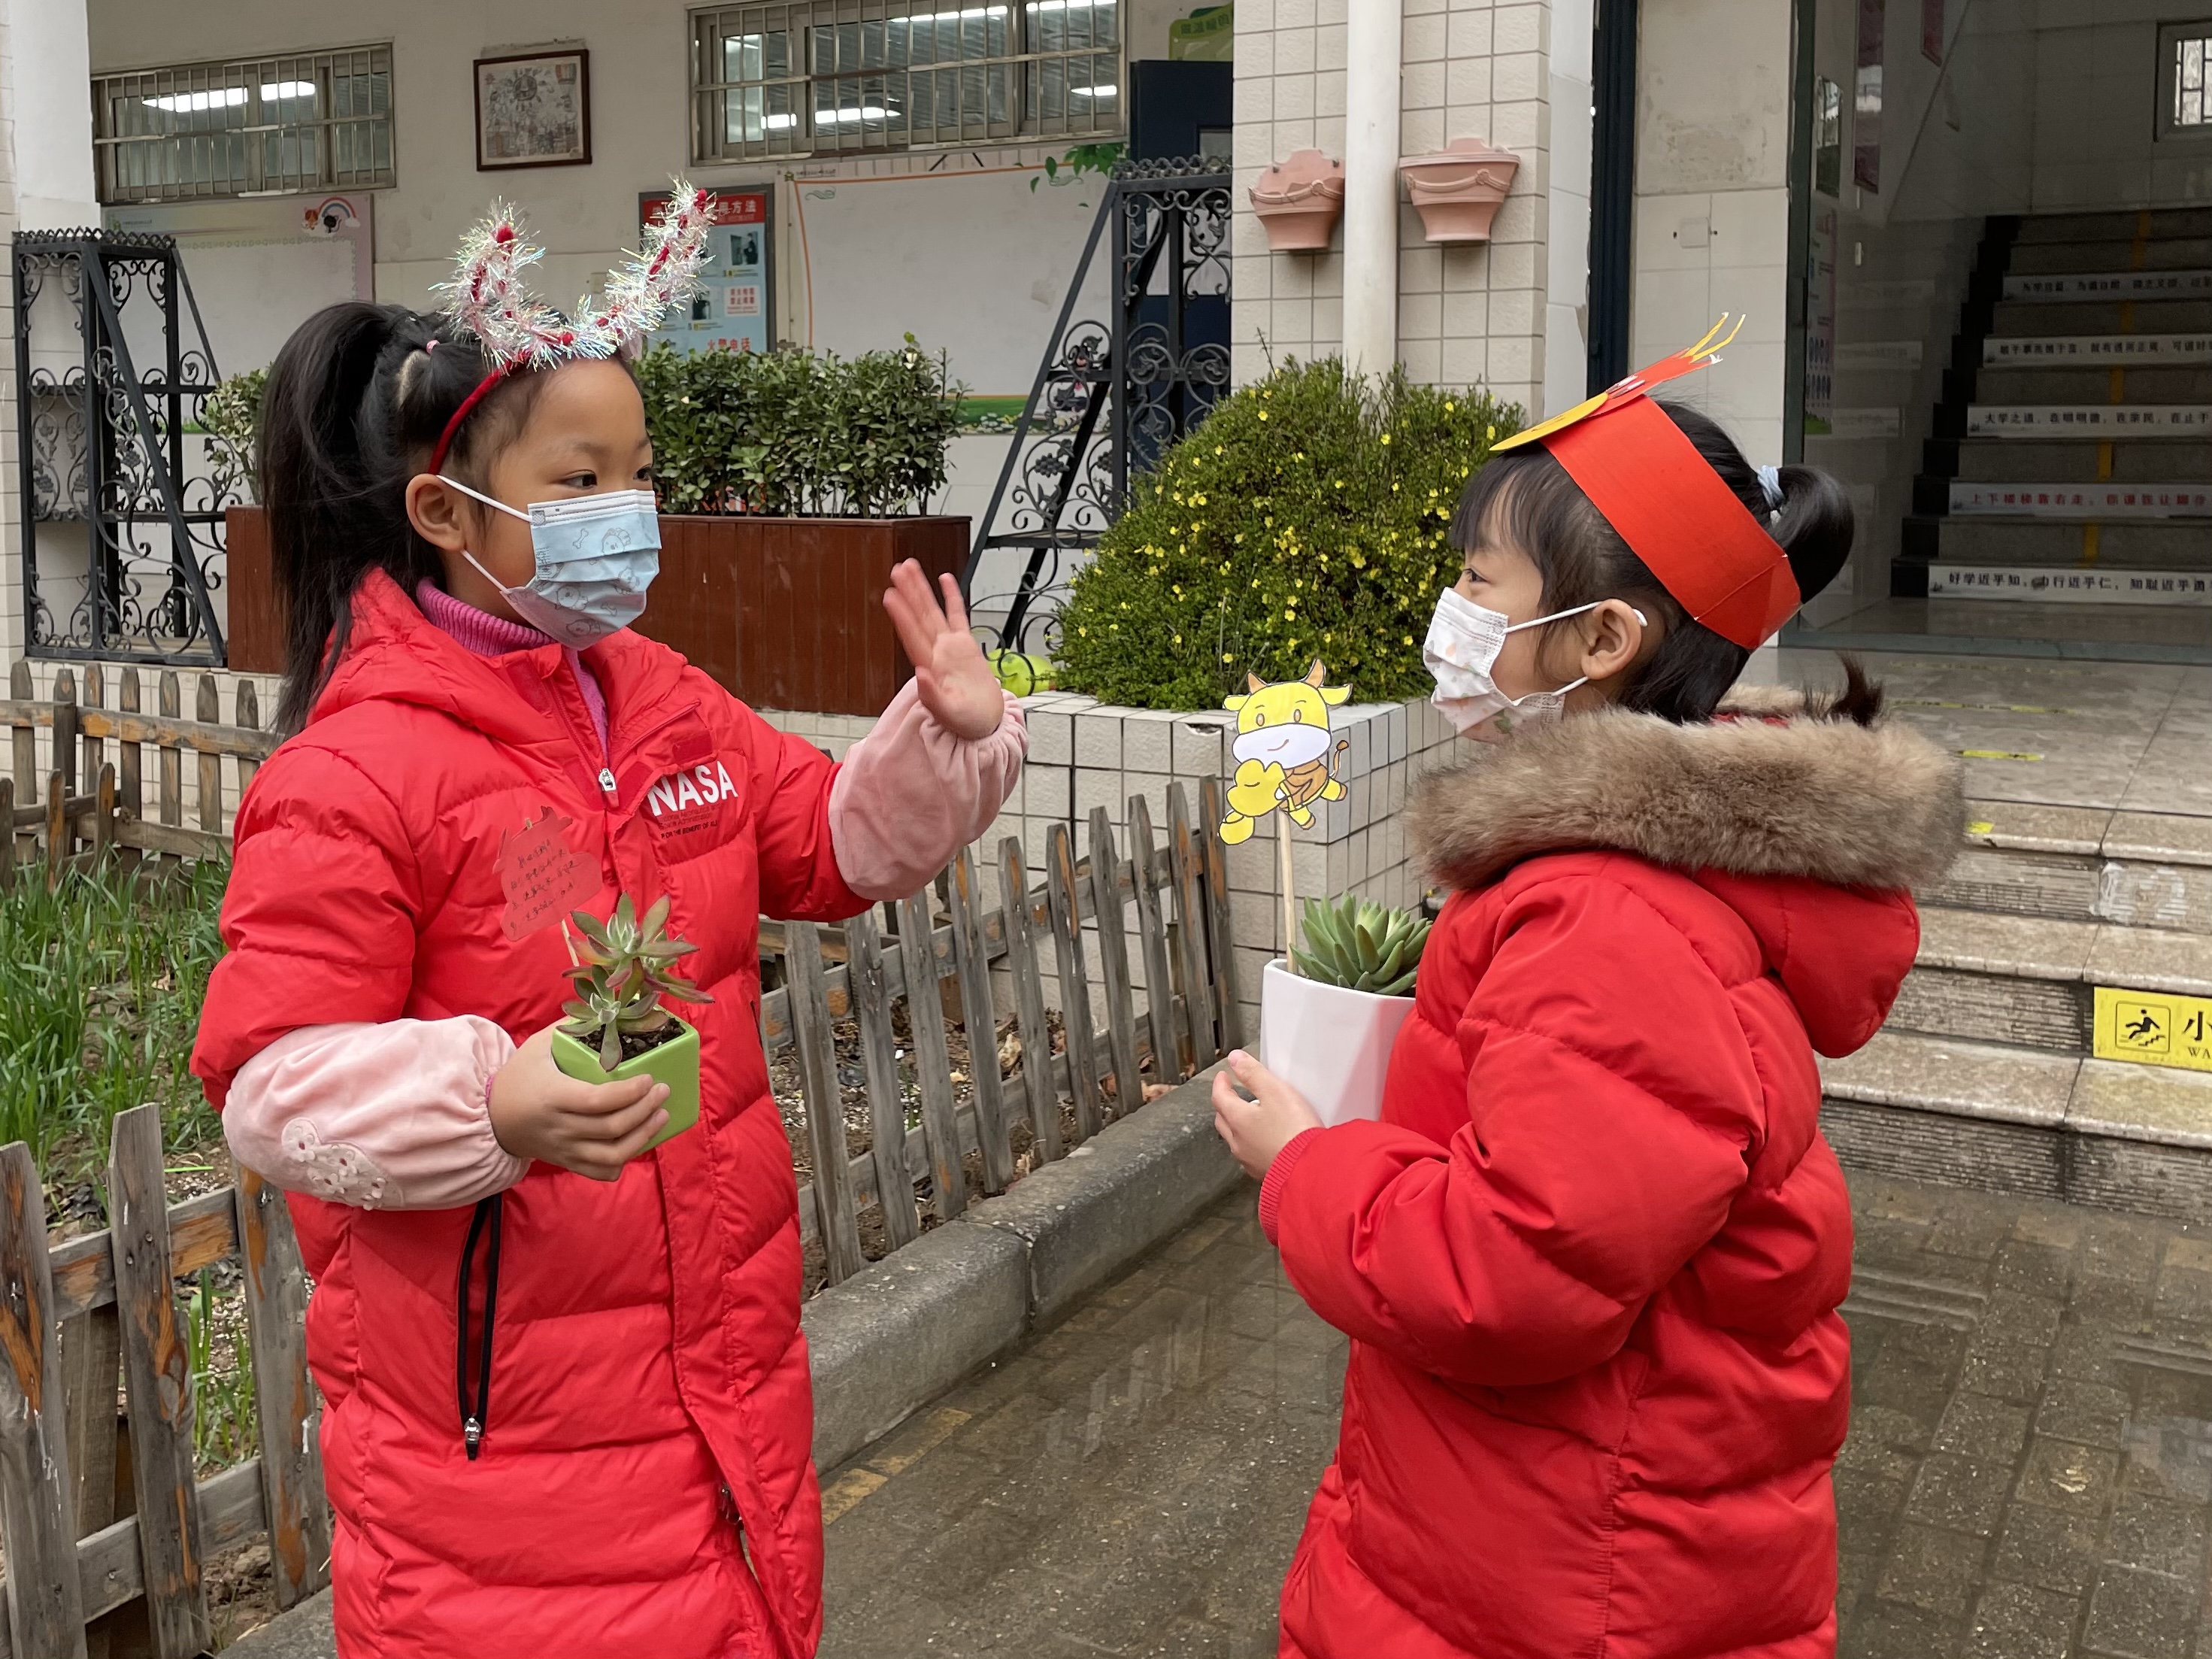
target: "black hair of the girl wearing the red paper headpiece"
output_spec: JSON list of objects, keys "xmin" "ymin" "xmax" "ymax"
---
[{"xmin": 1451, "ymin": 402, "xmax": 1883, "ymax": 726}]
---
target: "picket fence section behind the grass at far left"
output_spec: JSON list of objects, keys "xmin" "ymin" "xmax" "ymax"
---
[{"xmin": 0, "ymin": 660, "xmax": 277, "ymax": 883}]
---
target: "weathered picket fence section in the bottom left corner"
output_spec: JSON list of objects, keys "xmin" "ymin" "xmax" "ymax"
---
[{"xmin": 0, "ymin": 1106, "xmax": 329, "ymax": 1659}]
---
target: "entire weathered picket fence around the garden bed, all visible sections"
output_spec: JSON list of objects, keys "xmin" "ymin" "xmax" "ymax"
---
[{"xmin": 0, "ymin": 685, "xmax": 1243, "ymax": 1659}]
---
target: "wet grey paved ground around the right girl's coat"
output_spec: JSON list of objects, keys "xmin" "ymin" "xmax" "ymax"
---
[{"xmin": 823, "ymin": 1177, "xmax": 2212, "ymax": 1659}]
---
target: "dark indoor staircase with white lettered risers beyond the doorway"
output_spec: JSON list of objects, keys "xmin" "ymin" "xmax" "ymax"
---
[{"xmin": 1891, "ymin": 208, "xmax": 2212, "ymax": 608}]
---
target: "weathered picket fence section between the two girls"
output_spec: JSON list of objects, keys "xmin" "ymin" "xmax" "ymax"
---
[{"xmin": 761, "ymin": 778, "xmax": 1243, "ymax": 1285}]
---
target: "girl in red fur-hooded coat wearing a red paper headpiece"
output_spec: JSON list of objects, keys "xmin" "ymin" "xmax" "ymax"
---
[{"xmin": 1214, "ymin": 318, "xmax": 1962, "ymax": 1659}]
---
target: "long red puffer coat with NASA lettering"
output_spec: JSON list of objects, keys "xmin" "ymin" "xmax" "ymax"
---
[{"xmin": 192, "ymin": 575, "xmax": 865, "ymax": 1659}]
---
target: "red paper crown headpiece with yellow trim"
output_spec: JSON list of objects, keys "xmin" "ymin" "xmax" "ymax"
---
[{"xmin": 1493, "ymin": 317, "xmax": 1803, "ymax": 651}]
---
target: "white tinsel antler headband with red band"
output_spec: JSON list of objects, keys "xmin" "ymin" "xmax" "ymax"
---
[{"xmin": 429, "ymin": 179, "xmax": 714, "ymax": 473}]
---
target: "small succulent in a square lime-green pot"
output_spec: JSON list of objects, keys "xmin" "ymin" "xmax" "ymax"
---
[{"xmin": 553, "ymin": 893, "xmax": 714, "ymax": 1146}]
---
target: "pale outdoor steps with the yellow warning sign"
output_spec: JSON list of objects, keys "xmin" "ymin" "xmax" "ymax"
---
[{"xmin": 1820, "ymin": 800, "xmax": 2212, "ymax": 1219}]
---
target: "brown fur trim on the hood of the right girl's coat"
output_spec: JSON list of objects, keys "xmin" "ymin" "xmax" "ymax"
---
[{"xmin": 1407, "ymin": 690, "xmax": 1966, "ymax": 889}]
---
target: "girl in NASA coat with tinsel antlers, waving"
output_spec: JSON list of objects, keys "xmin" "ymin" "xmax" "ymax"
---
[{"xmin": 192, "ymin": 183, "xmax": 1026, "ymax": 1659}]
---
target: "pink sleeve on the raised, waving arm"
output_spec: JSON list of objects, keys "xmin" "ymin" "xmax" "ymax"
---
[{"xmin": 829, "ymin": 679, "xmax": 1029, "ymax": 898}]
